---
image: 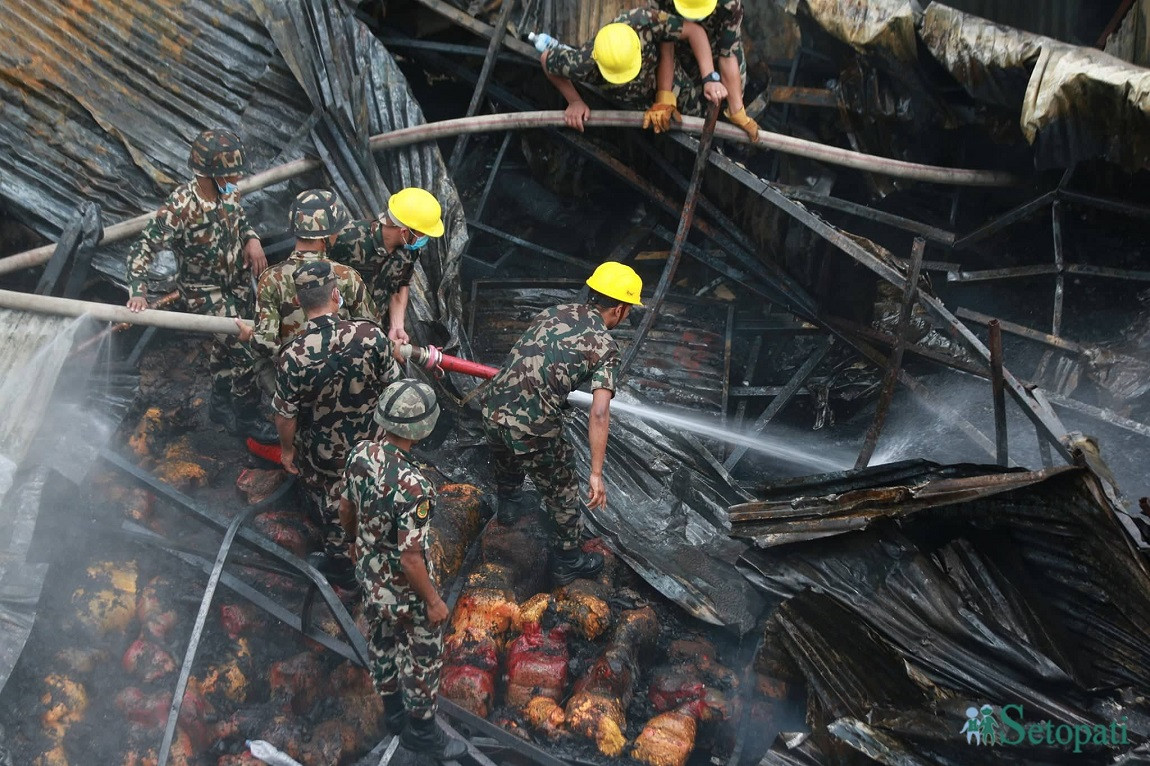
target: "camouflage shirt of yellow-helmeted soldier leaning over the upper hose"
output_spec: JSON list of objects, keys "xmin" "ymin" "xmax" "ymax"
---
[{"xmin": 543, "ymin": 8, "xmax": 699, "ymax": 112}]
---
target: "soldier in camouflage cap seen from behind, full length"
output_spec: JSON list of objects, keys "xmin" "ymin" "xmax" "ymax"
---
[{"xmin": 271, "ymin": 260, "xmax": 400, "ymax": 587}]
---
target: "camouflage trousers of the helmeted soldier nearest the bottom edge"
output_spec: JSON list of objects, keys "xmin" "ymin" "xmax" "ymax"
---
[{"xmin": 365, "ymin": 584, "xmax": 444, "ymax": 720}]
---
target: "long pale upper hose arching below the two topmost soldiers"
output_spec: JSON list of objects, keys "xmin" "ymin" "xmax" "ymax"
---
[{"xmin": 0, "ymin": 109, "xmax": 1019, "ymax": 274}]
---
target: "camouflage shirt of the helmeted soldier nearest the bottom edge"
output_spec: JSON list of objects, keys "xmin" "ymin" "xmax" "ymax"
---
[{"xmin": 343, "ymin": 441, "xmax": 436, "ymax": 610}]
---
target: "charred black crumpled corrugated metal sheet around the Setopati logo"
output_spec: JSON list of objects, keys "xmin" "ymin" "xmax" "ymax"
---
[{"xmin": 748, "ymin": 468, "xmax": 1150, "ymax": 765}]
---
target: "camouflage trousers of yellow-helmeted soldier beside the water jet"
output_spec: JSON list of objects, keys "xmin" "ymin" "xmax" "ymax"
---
[{"xmin": 483, "ymin": 421, "xmax": 583, "ymax": 551}]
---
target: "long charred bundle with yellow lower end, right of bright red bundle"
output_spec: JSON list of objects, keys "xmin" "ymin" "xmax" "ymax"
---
[{"xmin": 565, "ymin": 606, "xmax": 659, "ymax": 757}]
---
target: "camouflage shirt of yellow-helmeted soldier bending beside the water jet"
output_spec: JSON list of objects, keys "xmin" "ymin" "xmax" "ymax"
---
[{"xmin": 483, "ymin": 304, "xmax": 619, "ymax": 454}]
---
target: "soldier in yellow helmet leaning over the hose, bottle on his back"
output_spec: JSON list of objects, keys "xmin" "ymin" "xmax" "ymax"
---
[{"xmin": 541, "ymin": 7, "xmax": 727, "ymax": 133}]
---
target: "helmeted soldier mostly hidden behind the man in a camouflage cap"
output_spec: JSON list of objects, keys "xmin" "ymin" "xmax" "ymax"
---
[{"xmin": 242, "ymin": 189, "xmax": 378, "ymax": 359}]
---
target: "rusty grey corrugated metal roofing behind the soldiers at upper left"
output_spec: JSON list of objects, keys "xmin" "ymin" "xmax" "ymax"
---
[{"xmin": 0, "ymin": 0, "xmax": 466, "ymax": 337}]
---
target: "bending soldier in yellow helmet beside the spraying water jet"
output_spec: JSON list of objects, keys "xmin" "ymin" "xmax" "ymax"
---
[{"xmin": 482, "ymin": 261, "xmax": 643, "ymax": 585}]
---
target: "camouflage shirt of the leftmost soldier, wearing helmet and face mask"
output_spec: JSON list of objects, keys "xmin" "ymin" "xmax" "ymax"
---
[{"xmin": 128, "ymin": 179, "xmax": 256, "ymax": 303}]
